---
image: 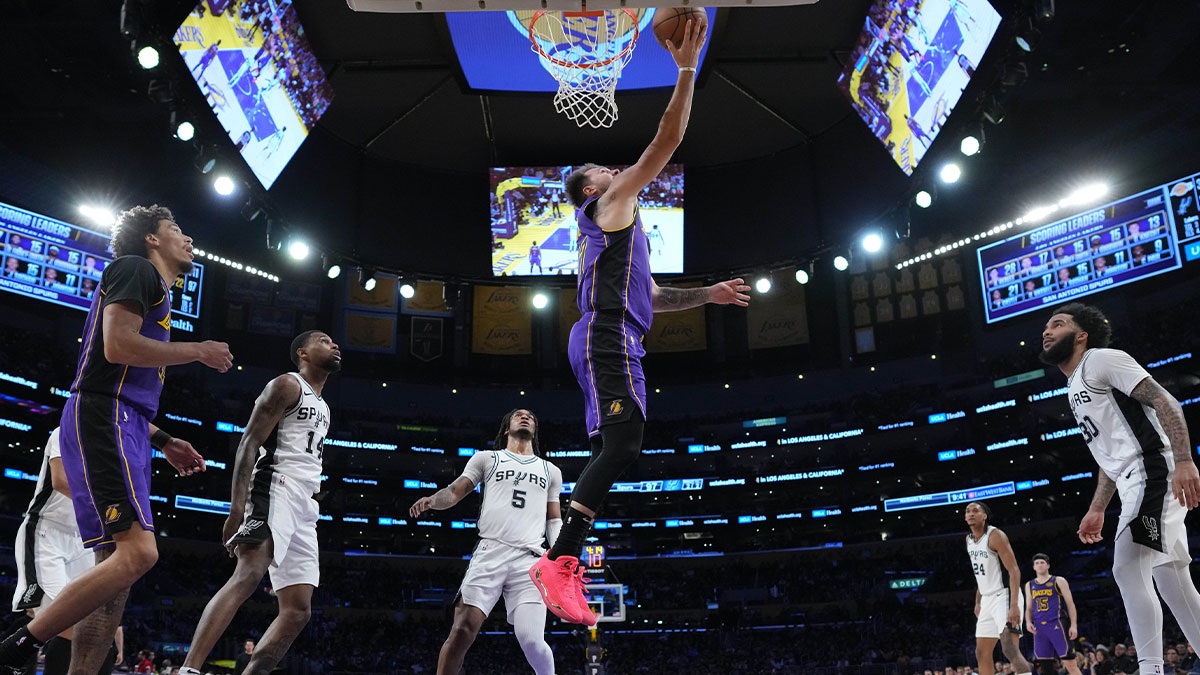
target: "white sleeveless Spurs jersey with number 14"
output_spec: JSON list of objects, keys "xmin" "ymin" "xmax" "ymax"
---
[{"xmin": 252, "ymin": 372, "xmax": 329, "ymax": 494}]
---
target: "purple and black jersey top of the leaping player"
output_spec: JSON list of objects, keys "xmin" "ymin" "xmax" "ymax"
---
[{"xmin": 575, "ymin": 197, "xmax": 654, "ymax": 338}]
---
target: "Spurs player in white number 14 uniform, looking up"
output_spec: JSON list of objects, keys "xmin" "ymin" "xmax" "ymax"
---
[{"xmin": 180, "ymin": 330, "xmax": 342, "ymax": 675}]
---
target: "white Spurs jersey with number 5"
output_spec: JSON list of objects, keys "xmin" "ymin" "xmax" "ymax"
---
[{"xmin": 462, "ymin": 450, "xmax": 563, "ymax": 552}]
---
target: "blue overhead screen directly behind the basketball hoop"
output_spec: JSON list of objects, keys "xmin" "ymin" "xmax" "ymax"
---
[{"xmin": 445, "ymin": 7, "xmax": 716, "ymax": 91}]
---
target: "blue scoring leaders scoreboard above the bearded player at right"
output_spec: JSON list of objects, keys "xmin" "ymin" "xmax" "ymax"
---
[{"xmin": 976, "ymin": 174, "xmax": 1200, "ymax": 323}]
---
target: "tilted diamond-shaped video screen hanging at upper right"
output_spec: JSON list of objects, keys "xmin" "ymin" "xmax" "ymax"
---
[{"xmin": 838, "ymin": 0, "xmax": 1000, "ymax": 175}]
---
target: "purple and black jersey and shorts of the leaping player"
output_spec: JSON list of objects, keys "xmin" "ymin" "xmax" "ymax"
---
[{"xmin": 568, "ymin": 197, "xmax": 654, "ymax": 436}]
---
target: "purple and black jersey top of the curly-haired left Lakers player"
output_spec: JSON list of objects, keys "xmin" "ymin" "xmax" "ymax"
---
[{"xmin": 71, "ymin": 256, "xmax": 170, "ymax": 419}]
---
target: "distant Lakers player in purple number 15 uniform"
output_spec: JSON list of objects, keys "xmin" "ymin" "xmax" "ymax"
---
[{"xmin": 1025, "ymin": 554, "xmax": 1080, "ymax": 675}]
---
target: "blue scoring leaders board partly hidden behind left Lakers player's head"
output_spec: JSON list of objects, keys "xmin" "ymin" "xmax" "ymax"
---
[{"xmin": 0, "ymin": 202, "xmax": 204, "ymax": 331}]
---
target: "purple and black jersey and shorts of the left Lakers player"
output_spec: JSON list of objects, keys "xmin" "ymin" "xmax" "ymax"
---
[{"xmin": 60, "ymin": 256, "xmax": 170, "ymax": 548}]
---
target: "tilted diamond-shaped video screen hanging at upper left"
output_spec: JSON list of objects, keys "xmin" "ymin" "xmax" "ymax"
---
[{"xmin": 175, "ymin": 0, "xmax": 334, "ymax": 189}]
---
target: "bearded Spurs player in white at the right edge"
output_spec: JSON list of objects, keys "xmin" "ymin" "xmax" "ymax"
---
[{"xmin": 1039, "ymin": 303, "xmax": 1200, "ymax": 674}]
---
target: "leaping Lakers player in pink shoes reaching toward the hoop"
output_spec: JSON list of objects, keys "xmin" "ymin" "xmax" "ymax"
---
[{"xmin": 529, "ymin": 20, "xmax": 750, "ymax": 623}]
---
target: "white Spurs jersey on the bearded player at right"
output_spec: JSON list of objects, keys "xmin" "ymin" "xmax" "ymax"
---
[{"xmin": 1067, "ymin": 350, "xmax": 1174, "ymax": 480}]
